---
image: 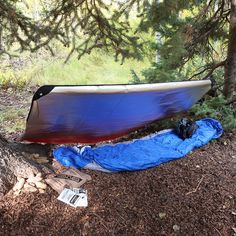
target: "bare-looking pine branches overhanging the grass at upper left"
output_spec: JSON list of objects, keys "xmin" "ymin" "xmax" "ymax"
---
[{"xmin": 0, "ymin": 0, "xmax": 142, "ymax": 61}]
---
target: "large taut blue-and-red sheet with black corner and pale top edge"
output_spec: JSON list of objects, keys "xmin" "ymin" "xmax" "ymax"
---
[{"xmin": 22, "ymin": 80, "xmax": 211, "ymax": 144}]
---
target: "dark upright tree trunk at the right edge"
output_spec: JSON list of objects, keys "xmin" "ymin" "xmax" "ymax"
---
[{"xmin": 224, "ymin": 0, "xmax": 236, "ymax": 100}]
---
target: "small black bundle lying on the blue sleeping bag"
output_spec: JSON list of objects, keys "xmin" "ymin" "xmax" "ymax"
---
[{"xmin": 175, "ymin": 118, "xmax": 198, "ymax": 139}]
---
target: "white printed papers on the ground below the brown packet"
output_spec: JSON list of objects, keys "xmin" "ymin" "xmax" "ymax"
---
[{"xmin": 57, "ymin": 188, "xmax": 88, "ymax": 207}]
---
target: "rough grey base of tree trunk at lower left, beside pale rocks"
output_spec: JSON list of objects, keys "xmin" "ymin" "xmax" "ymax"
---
[{"xmin": 0, "ymin": 135, "xmax": 49, "ymax": 198}]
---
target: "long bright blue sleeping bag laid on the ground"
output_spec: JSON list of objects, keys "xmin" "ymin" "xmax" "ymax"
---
[{"xmin": 53, "ymin": 118, "xmax": 223, "ymax": 172}]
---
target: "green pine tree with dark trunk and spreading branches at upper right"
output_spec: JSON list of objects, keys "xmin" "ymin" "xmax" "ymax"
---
[{"xmin": 139, "ymin": 0, "xmax": 236, "ymax": 100}]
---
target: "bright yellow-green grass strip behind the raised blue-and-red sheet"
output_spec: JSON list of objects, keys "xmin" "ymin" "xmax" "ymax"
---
[{"xmin": 0, "ymin": 50, "xmax": 148, "ymax": 88}]
